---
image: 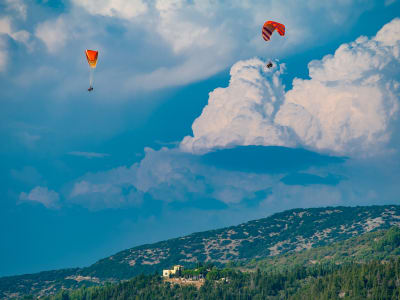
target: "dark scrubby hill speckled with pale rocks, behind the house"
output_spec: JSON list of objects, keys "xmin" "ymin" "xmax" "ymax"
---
[{"xmin": 0, "ymin": 205, "xmax": 400, "ymax": 295}]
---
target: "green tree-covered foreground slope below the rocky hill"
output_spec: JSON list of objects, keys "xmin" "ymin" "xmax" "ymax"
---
[{"xmin": 41, "ymin": 227, "xmax": 400, "ymax": 300}]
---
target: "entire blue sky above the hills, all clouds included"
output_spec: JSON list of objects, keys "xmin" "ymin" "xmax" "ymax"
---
[{"xmin": 0, "ymin": 0, "xmax": 400, "ymax": 276}]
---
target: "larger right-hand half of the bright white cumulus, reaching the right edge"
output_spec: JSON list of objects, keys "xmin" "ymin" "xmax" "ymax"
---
[{"xmin": 275, "ymin": 19, "xmax": 400, "ymax": 155}]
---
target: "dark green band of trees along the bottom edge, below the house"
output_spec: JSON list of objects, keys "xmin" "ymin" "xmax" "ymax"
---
[{"xmin": 28, "ymin": 258, "xmax": 400, "ymax": 300}]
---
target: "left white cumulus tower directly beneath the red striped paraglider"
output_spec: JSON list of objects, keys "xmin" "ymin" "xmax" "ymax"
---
[{"xmin": 181, "ymin": 59, "xmax": 294, "ymax": 152}]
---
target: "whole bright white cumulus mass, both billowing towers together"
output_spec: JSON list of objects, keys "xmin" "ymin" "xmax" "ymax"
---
[{"xmin": 181, "ymin": 19, "xmax": 400, "ymax": 156}]
